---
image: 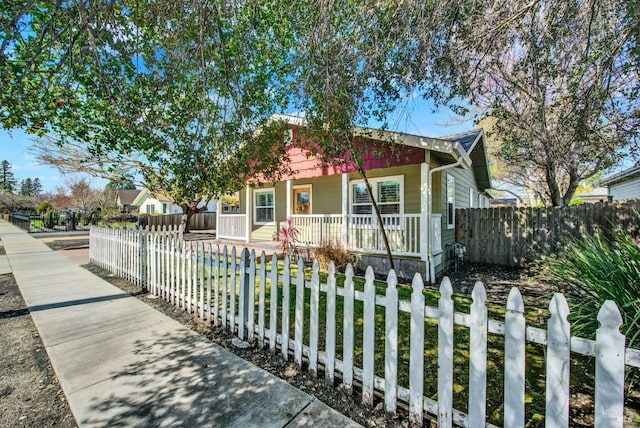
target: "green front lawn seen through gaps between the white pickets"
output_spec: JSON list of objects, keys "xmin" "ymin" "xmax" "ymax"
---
[{"xmin": 175, "ymin": 252, "xmax": 560, "ymax": 426}]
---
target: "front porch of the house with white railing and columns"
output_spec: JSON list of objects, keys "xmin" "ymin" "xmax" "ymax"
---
[{"xmin": 217, "ymin": 171, "xmax": 442, "ymax": 265}]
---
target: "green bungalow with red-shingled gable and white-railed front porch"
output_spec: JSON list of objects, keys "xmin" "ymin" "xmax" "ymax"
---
[{"xmin": 217, "ymin": 116, "xmax": 491, "ymax": 282}]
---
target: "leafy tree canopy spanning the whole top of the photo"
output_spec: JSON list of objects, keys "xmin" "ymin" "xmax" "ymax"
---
[{"xmin": 0, "ymin": 0, "xmax": 640, "ymax": 210}]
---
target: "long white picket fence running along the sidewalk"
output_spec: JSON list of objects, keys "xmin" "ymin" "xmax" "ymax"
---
[{"xmin": 90, "ymin": 228, "xmax": 640, "ymax": 427}]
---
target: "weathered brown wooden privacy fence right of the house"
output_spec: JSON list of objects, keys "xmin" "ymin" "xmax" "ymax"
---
[{"xmin": 456, "ymin": 199, "xmax": 640, "ymax": 266}]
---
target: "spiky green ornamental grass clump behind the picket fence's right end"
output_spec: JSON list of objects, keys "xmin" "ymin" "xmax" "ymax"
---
[{"xmin": 549, "ymin": 230, "xmax": 640, "ymax": 348}]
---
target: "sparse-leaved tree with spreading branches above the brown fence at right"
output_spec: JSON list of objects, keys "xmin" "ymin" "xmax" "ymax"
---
[{"xmin": 438, "ymin": 0, "xmax": 640, "ymax": 206}]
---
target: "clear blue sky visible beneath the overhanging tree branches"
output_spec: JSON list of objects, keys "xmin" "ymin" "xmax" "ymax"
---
[{"xmin": 0, "ymin": 100, "xmax": 474, "ymax": 192}]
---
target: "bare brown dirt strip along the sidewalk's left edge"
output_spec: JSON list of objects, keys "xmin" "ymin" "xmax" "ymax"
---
[{"xmin": 0, "ymin": 272, "xmax": 77, "ymax": 427}]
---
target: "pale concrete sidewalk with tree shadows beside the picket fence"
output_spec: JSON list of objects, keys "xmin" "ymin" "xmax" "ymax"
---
[{"xmin": 0, "ymin": 220, "xmax": 358, "ymax": 427}]
